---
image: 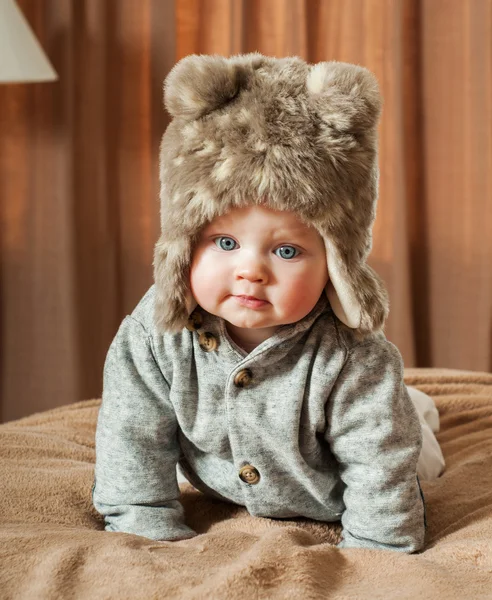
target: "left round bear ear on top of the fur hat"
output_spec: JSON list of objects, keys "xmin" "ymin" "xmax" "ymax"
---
[{"xmin": 164, "ymin": 54, "xmax": 240, "ymax": 120}]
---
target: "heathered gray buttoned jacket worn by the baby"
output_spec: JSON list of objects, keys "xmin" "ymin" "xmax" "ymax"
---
[{"xmin": 93, "ymin": 287, "xmax": 425, "ymax": 552}]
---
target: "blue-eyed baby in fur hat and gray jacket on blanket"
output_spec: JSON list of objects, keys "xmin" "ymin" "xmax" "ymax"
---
[{"xmin": 93, "ymin": 54, "xmax": 444, "ymax": 552}]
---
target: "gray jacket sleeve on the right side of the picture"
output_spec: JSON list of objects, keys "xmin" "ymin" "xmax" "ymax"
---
[{"xmin": 327, "ymin": 334, "xmax": 425, "ymax": 553}]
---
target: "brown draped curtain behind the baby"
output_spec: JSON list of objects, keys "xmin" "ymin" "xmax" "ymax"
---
[{"xmin": 0, "ymin": 0, "xmax": 492, "ymax": 420}]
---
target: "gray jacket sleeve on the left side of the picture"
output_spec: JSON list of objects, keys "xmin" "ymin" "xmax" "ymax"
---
[{"xmin": 93, "ymin": 317, "xmax": 196, "ymax": 540}]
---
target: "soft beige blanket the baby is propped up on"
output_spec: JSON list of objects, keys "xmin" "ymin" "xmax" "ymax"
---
[{"xmin": 0, "ymin": 369, "xmax": 492, "ymax": 600}]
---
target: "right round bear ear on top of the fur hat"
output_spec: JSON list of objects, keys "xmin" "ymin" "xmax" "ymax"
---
[{"xmin": 306, "ymin": 61, "xmax": 382, "ymax": 131}]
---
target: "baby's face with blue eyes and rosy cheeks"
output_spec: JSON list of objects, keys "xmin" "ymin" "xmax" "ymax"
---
[{"xmin": 190, "ymin": 206, "xmax": 328, "ymax": 338}]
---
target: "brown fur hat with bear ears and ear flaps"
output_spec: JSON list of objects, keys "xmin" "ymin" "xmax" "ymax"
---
[{"xmin": 154, "ymin": 53, "xmax": 388, "ymax": 334}]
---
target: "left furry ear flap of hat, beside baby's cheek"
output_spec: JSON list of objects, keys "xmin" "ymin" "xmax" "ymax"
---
[{"xmin": 154, "ymin": 235, "xmax": 196, "ymax": 333}]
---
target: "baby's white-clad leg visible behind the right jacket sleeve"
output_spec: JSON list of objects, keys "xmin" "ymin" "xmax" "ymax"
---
[{"xmin": 407, "ymin": 386, "xmax": 445, "ymax": 481}]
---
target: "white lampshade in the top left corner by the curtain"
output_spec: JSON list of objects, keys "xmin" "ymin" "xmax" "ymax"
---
[{"xmin": 0, "ymin": 0, "xmax": 58, "ymax": 83}]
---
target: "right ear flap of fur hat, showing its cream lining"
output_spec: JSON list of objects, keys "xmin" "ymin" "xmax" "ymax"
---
[{"xmin": 324, "ymin": 237, "xmax": 389, "ymax": 333}]
